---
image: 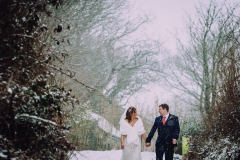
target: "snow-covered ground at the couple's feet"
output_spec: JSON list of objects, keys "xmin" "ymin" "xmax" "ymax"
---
[{"xmin": 71, "ymin": 150, "xmax": 182, "ymax": 160}]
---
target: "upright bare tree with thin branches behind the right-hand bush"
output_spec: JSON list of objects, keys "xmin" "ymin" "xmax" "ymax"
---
[{"xmin": 162, "ymin": 1, "xmax": 239, "ymax": 117}]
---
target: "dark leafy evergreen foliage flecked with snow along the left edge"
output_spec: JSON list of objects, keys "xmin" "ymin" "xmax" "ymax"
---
[{"xmin": 0, "ymin": 0, "xmax": 74, "ymax": 159}]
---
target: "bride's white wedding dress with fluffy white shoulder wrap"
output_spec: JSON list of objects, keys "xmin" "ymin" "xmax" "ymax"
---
[{"xmin": 120, "ymin": 116, "xmax": 145, "ymax": 160}]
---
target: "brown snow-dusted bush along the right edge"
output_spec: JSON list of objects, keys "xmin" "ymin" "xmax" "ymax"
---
[{"xmin": 187, "ymin": 47, "xmax": 240, "ymax": 160}]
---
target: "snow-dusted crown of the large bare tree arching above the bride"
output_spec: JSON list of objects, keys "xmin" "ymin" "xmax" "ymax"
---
[{"xmin": 50, "ymin": 0, "xmax": 162, "ymax": 112}]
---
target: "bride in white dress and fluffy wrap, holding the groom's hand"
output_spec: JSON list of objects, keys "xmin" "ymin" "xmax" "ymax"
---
[{"xmin": 119, "ymin": 107, "xmax": 146, "ymax": 160}]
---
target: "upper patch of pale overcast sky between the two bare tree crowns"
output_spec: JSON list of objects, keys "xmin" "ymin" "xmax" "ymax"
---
[{"xmin": 129, "ymin": 0, "xmax": 240, "ymax": 52}]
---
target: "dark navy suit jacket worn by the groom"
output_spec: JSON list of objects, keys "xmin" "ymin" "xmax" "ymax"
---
[{"xmin": 146, "ymin": 114, "xmax": 180, "ymax": 147}]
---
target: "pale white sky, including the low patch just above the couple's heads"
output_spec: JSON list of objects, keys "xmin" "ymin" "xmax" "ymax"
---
[{"xmin": 126, "ymin": 0, "xmax": 240, "ymax": 112}]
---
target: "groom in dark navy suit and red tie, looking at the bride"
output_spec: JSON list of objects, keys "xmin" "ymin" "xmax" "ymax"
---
[{"xmin": 145, "ymin": 104, "xmax": 180, "ymax": 160}]
